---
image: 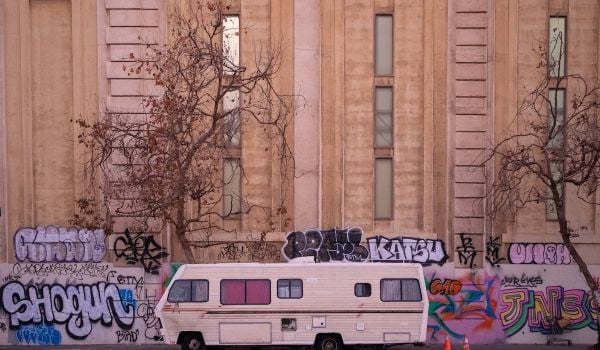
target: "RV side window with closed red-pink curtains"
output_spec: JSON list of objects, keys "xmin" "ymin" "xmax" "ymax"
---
[{"xmin": 221, "ymin": 280, "xmax": 271, "ymax": 305}]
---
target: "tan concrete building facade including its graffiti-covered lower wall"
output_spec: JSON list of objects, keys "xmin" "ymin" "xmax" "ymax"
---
[{"xmin": 0, "ymin": 0, "xmax": 600, "ymax": 344}]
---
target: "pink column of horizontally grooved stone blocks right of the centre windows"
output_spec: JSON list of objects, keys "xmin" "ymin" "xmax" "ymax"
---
[{"xmin": 449, "ymin": 0, "xmax": 491, "ymax": 267}]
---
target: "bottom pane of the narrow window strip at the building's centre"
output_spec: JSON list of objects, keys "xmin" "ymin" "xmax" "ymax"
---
[{"xmin": 375, "ymin": 158, "xmax": 394, "ymax": 219}]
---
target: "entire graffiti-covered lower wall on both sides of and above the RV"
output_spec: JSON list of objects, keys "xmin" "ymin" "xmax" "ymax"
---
[{"xmin": 0, "ymin": 226, "xmax": 600, "ymax": 345}]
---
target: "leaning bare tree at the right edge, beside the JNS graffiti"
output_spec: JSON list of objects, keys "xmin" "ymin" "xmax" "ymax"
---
[{"xmin": 485, "ymin": 31, "xmax": 600, "ymax": 340}]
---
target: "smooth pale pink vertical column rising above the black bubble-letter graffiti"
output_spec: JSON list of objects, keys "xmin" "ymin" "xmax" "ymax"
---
[{"xmin": 294, "ymin": 0, "xmax": 321, "ymax": 230}]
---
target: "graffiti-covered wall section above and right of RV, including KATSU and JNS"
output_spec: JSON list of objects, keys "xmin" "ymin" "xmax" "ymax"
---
[{"xmin": 282, "ymin": 227, "xmax": 600, "ymax": 344}]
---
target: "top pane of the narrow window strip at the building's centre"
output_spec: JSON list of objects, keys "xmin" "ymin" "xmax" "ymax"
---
[{"xmin": 375, "ymin": 15, "xmax": 394, "ymax": 75}]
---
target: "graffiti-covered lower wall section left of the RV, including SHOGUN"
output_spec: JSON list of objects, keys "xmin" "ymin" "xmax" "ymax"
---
[{"xmin": 0, "ymin": 226, "xmax": 172, "ymax": 345}]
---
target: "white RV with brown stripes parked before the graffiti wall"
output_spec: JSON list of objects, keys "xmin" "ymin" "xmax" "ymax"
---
[{"xmin": 156, "ymin": 258, "xmax": 428, "ymax": 350}]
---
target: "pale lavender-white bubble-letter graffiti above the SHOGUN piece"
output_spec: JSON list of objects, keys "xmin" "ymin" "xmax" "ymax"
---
[{"xmin": 15, "ymin": 226, "xmax": 106, "ymax": 262}]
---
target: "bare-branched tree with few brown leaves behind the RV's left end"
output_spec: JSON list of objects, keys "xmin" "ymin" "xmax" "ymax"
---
[{"xmin": 76, "ymin": 1, "xmax": 291, "ymax": 262}]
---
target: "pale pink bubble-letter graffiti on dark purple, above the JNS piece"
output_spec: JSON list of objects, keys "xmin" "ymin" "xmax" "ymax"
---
[{"xmin": 508, "ymin": 243, "xmax": 571, "ymax": 265}]
